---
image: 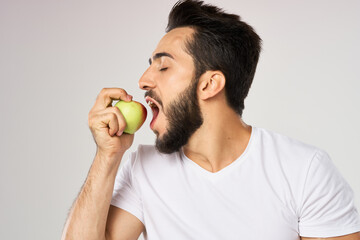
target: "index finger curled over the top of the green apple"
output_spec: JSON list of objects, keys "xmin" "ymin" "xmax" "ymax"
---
[{"xmin": 92, "ymin": 88, "xmax": 132, "ymax": 111}]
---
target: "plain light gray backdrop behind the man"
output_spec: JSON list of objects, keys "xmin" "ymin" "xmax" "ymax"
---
[{"xmin": 0, "ymin": 0, "xmax": 360, "ymax": 240}]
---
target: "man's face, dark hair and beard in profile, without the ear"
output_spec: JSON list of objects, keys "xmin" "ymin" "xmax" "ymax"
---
[{"xmin": 139, "ymin": 1, "xmax": 261, "ymax": 153}]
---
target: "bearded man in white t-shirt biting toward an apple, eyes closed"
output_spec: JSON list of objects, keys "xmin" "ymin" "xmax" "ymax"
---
[{"xmin": 63, "ymin": 0, "xmax": 360, "ymax": 240}]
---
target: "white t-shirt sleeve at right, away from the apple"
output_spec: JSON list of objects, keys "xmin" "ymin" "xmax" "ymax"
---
[{"xmin": 299, "ymin": 151, "xmax": 360, "ymax": 238}]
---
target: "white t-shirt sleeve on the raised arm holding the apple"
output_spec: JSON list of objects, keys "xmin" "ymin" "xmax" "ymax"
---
[{"xmin": 110, "ymin": 153, "xmax": 144, "ymax": 223}]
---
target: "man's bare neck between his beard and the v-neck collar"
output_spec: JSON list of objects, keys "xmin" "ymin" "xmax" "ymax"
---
[{"xmin": 183, "ymin": 101, "xmax": 251, "ymax": 172}]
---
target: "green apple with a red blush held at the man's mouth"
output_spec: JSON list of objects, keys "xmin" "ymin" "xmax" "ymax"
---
[{"xmin": 115, "ymin": 100, "xmax": 147, "ymax": 134}]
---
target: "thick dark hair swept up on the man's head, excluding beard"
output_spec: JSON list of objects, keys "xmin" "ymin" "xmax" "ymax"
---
[{"xmin": 166, "ymin": 0, "xmax": 261, "ymax": 116}]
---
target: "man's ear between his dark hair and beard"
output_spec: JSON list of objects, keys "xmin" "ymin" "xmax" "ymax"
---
[{"xmin": 198, "ymin": 71, "xmax": 225, "ymax": 100}]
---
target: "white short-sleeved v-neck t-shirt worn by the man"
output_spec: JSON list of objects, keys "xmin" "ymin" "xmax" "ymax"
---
[{"xmin": 111, "ymin": 127, "xmax": 360, "ymax": 240}]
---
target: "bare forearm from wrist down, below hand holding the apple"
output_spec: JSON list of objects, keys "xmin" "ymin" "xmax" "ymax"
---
[{"xmin": 62, "ymin": 154, "xmax": 122, "ymax": 240}]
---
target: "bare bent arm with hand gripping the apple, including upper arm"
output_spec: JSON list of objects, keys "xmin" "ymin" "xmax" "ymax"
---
[{"xmin": 62, "ymin": 88, "xmax": 144, "ymax": 240}]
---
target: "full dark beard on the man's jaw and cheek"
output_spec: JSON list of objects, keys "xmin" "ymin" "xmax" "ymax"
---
[{"xmin": 155, "ymin": 79, "xmax": 203, "ymax": 154}]
